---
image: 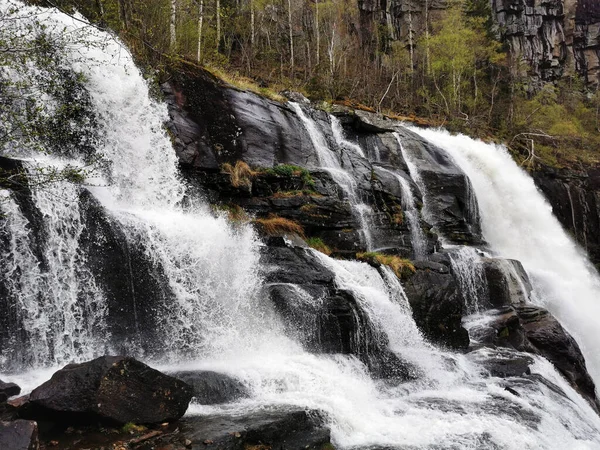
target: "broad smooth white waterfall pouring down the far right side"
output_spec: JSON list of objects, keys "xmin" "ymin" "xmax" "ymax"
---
[{"xmin": 413, "ymin": 128, "xmax": 600, "ymax": 385}]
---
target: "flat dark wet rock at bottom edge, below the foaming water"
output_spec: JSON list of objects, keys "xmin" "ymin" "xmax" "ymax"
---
[{"xmin": 139, "ymin": 409, "xmax": 331, "ymax": 450}]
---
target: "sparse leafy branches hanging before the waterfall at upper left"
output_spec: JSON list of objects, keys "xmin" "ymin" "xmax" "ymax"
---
[{"xmin": 0, "ymin": 0, "xmax": 105, "ymax": 191}]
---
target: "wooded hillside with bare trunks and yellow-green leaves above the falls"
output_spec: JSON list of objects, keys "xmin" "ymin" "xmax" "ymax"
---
[{"xmin": 16, "ymin": 0, "xmax": 600, "ymax": 170}]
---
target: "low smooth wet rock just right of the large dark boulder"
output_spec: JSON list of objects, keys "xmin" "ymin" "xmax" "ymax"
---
[{"xmin": 169, "ymin": 371, "xmax": 248, "ymax": 405}]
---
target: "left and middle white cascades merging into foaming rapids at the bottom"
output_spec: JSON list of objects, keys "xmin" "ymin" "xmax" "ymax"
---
[{"xmin": 0, "ymin": 0, "xmax": 600, "ymax": 449}]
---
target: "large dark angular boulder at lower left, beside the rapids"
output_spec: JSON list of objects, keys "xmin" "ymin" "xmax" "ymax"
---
[{"xmin": 26, "ymin": 356, "xmax": 192, "ymax": 424}]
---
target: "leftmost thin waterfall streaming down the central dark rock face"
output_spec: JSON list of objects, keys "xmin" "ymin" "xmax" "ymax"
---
[{"xmin": 290, "ymin": 102, "xmax": 373, "ymax": 250}]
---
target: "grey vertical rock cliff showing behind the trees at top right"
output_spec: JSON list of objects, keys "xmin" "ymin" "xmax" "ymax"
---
[{"xmin": 359, "ymin": 0, "xmax": 600, "ymax": 84}]
